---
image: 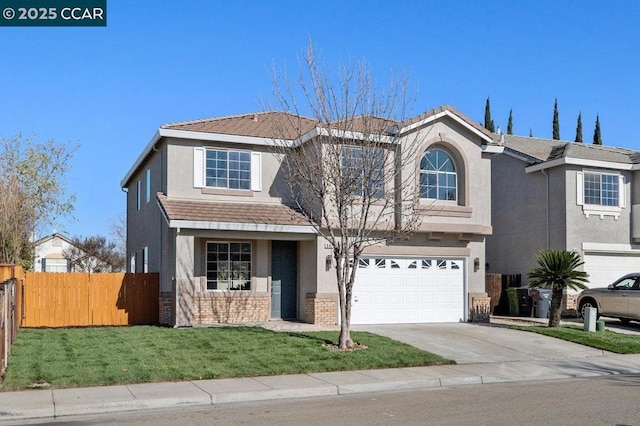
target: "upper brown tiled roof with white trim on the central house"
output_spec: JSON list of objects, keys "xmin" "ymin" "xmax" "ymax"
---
[{"xmin": 120, "ymin": 105, "xmax": 497, "ymax": 188}]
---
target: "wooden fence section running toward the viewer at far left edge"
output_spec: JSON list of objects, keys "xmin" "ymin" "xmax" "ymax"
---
[{"xmin": 0, "ymin": 265, "xmax": 23, "ymax": 372}]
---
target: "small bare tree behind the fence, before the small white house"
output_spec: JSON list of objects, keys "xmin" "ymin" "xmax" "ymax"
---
[{"xmin": 63, "ymin": 235, "xmax": 125, "ymax": 274}]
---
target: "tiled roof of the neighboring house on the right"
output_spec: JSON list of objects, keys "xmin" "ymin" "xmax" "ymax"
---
[{"xmin": 496, "ymin": 135, "xmax": 640, "ymax": 170}]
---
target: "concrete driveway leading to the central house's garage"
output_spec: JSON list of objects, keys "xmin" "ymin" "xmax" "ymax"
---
[{"xmin": 352, "ymin": 323, "xmax": 609, "ymax": 364}]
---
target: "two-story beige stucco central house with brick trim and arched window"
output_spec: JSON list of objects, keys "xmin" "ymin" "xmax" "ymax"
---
[{"xmin": 121, "ymin": 106, "xmax": 501, "ymax": 326}]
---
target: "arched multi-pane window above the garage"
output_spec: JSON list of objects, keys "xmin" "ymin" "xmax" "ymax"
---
[{"xmin": 420, "ymin": 148, "xmax": 458, "ymax": 201}]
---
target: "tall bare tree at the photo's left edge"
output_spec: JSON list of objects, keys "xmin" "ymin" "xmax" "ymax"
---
[{"xmin": 0, "ymin": 135, "xmax": 77, "ymax": 267}]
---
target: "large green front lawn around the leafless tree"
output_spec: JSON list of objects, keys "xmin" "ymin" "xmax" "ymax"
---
[{"xmin": 2, "ymin": 326, "xmax": 453, "ymax": 390}]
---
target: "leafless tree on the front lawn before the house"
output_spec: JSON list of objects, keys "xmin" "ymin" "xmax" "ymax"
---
[{"xmin": 272, "ymin": 45, "xmax": 424, "ymax": 349}]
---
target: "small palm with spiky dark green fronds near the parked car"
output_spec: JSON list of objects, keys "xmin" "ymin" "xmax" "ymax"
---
[{"xmin": 527, "ymin": 249, "xmax": 589, "ymax": 327}]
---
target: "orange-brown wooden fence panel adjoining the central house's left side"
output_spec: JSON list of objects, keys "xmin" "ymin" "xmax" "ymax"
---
[{"xmin": 22, "ymin": 272, "xmax": 159, "ymax": 327}]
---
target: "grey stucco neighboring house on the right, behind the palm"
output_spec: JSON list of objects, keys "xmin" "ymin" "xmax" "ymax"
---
[{"xmin": 487, "ymin": 135, "xmax": 640, "ymax": 287}]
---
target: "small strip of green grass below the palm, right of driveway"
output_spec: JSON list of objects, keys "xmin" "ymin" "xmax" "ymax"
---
[{"xmin": 514, "ymin": 326, "xmax": 640, "ymax": 354}]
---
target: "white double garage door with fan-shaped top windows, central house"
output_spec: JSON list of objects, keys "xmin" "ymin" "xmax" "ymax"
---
[{"xmin": 351, "ymin": 257, "xmax": 464, "ymax": 324}]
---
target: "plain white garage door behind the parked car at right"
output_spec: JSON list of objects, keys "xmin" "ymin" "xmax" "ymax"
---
[{"xmin": 584, "ymin": 253, "xmax": 640, "ymax": 288}]
